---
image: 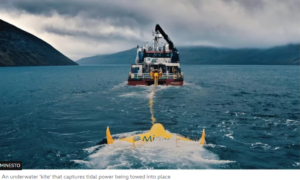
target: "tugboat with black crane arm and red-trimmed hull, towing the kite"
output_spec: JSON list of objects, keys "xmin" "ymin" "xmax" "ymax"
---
[{"xmin": 127, "ymin": 24, "xmax": 184, "ymax": 86}]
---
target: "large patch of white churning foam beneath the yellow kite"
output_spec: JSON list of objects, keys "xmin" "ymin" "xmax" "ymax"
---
[{"xmin": 80, "ymin": 131, "xmax": 233, "ymax": 169}]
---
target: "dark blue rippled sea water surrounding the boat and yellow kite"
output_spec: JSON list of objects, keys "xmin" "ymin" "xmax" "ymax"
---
[{"xmin": 0, "ymin": 65, "xmax": 300, "ymax": 169}]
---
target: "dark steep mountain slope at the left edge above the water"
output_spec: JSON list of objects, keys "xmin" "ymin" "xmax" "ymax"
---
[{"xmin": 0, "ymin": 19, "xmax": 77, "ymax": 66}]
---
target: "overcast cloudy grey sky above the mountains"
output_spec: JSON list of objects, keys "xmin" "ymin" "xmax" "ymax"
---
[{"xmin": 0, "ymin": 0, "xmax": 300, "ymax": 60}]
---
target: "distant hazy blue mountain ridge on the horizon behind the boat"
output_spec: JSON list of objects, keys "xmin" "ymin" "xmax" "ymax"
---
[{"xmin": 77, "ymin": 44, "xmax": 300, "ymax": 65}]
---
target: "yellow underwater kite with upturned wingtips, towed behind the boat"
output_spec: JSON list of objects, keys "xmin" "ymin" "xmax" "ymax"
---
[{"xmin": 106, "ymin": 123, "xmax": 206, "ymax": 147}]
